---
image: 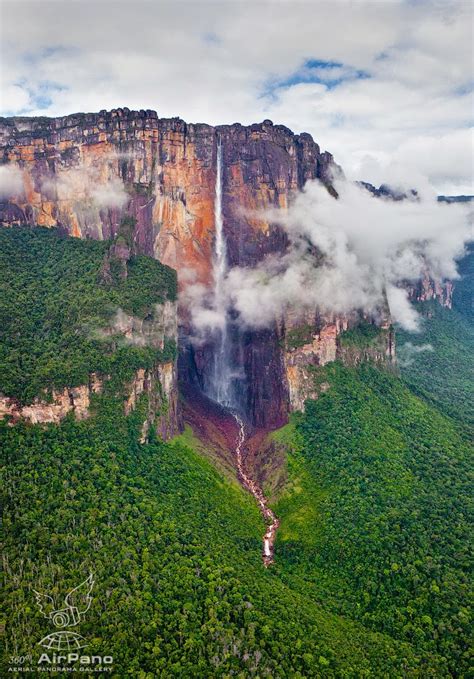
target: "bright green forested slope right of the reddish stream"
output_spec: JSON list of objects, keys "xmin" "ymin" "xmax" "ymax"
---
[{"xmin": 274, "ymin": 364, "xmax": 472, "ymax": 676}]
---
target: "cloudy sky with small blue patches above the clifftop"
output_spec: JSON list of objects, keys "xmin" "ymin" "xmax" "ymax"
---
[{"xmin": 0, "ymin": 0, "xmax": 474, "ymax": 193}]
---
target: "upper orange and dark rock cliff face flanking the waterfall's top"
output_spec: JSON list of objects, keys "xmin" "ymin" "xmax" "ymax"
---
[{"xmin": 0, "ymin": 109, "xmax": 333, "ymax": 281}]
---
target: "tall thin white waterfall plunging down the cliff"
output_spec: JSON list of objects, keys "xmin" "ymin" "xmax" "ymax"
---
[{"xmin": 208, "ymin": 139, "xmax": 235, "ymax": 407}]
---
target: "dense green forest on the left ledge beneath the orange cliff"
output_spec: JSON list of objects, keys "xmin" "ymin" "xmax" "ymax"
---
[{"xmin": 0, "ymin": 226, "xmax": 177, "ymax": 403}]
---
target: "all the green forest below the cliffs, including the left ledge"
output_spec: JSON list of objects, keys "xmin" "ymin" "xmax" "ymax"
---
[{"xmin": 0, "ymin": 229, "xmax": 472, "ymax": 679}]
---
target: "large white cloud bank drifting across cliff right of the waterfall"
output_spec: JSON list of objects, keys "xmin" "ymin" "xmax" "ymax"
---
[{"xmin": 187, "ymin": 180, "xmax": 473, "ymax": 332}]
